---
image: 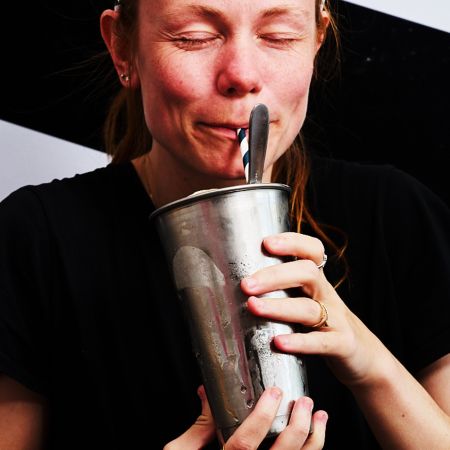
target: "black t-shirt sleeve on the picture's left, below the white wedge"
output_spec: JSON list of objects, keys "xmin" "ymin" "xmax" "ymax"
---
[{"xmin": 0, "ymin": 188, "xmax": 55, "ymax": 395}]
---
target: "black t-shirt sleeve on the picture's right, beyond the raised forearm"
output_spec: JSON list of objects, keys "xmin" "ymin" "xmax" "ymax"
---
[{"xmin": 383, "ymin": 169, "xmax": 450, "ymax": 372}]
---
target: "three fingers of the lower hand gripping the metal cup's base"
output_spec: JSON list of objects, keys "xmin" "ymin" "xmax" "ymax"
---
[{"xmin": 223, "ymin": 388, "xmax": 328, "ymax": 450}]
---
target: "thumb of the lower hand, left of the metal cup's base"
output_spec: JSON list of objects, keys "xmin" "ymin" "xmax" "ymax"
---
[{"xmin": 164, "ymin": 385, "xmax": 216, "ymax": 450}]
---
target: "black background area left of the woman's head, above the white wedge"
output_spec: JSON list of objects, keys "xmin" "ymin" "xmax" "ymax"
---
[{"xmin": 0, "ymin": 0, "xmax": 111, "ymax": 148}]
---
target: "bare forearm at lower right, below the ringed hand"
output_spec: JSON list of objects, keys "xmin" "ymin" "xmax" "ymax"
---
[{"xmin": 350, "ymin": 343, "xmax": 450, "ymax": 450}]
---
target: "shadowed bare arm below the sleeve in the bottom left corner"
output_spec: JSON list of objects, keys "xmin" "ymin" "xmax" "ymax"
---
[{"xmin": 0, "ymin": 373, "xmax": 46, "ymax": 450}]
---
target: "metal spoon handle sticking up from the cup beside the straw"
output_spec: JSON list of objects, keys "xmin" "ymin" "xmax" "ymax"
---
[{"xmin": 248, "ymin": 103, "xmax": 269, "ymax": 184}]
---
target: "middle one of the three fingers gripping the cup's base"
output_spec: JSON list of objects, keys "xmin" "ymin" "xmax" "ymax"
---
[{"xmin": 272, "ymin": 397, "xmax": 313, "ymax": 450}]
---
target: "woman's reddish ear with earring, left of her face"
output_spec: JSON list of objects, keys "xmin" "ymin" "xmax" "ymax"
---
[{"xmin": 100, "ymin": 9, "xmax": 139, "ymax": 88}]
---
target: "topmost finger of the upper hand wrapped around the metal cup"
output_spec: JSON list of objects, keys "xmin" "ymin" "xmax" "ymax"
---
[{"xmin": 263, "ymin": 232, "xmax": 325, "ymax": 265}]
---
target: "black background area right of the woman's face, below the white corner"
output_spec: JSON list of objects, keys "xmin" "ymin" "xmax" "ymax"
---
[{"xmin": 306, "ymin": 2, "xmax": 450, "ymax": 204}]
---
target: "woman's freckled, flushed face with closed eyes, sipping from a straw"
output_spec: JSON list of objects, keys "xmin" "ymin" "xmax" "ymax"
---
[{"xmin": 135, "ymin": 0, "xmax": 319, "ymax": 180}]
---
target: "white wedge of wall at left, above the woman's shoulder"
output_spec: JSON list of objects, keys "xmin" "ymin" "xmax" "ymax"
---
[{"xmin": 0, "ymin": 120, "xmax": 108, "ymax": 200}]
